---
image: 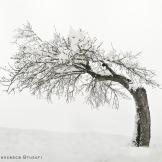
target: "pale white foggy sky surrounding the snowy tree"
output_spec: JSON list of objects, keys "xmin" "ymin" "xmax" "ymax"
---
[{"xmin": 0, "ymin": 0, "xmax": 162, "ymax": 135}]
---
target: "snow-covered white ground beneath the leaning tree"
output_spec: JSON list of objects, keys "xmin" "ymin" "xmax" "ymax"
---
[{"xmin": 0, "ymin": 128, "xmax": 162, "ymax": 162}]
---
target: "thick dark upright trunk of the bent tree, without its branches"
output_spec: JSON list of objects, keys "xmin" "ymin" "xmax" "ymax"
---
[{"xmin": 131, "ymin": 87, "xmax": 151, "ymax": 147}]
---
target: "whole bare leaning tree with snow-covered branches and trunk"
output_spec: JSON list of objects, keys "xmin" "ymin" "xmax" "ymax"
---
[{"xmin": 1, "ymin": 23, "xmax": 159, "ymax": 146}]
